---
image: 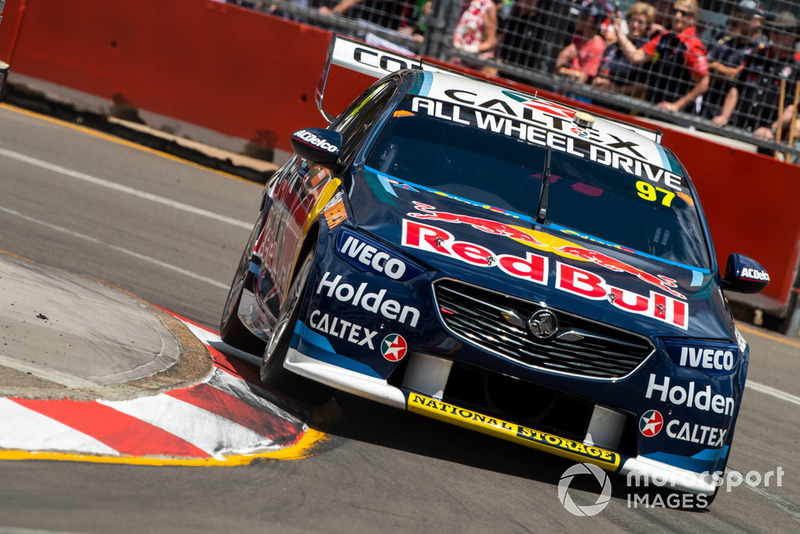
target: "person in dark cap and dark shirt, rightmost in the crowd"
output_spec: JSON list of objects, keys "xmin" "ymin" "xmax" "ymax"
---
[{"xmin": 723, "ymin": 11, "xmax": 800, "ymax": 152}]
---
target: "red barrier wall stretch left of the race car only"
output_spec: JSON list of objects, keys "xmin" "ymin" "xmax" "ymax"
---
[{"xmin": 0, "ymin": 0, "xmax": 330, "ymax": 156}]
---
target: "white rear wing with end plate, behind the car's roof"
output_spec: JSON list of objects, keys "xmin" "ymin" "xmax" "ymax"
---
[{"xmin": 315, "ymin": 34, "xmax": 662, "ymax": 144}]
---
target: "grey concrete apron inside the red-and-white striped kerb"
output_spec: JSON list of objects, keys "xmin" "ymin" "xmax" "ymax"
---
[{"xmin": 0, "ymin": 251, "xmax": 213, "ymax": 401}]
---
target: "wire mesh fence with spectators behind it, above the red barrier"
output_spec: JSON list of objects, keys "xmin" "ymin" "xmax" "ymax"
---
[{"xmin": 229, "ymin": 0, "xmax": 800, "ymax": 162}]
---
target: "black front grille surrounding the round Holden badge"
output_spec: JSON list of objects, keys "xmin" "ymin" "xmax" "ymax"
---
[{"xmin": 434, "ymin": 280, "xmax": 653, "ymax": 379}]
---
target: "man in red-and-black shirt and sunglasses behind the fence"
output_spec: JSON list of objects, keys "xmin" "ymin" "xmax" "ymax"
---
[{"xmin": 615, "ymin": 0, "xmax": 709, "ymax": 113}]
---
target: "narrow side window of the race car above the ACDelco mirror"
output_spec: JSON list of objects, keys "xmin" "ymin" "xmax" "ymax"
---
[{"xmin": 331, "ymin": 80, "xmax": 397, "ymax": 161}]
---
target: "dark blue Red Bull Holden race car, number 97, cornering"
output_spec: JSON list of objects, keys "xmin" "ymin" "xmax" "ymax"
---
[{"xmin": 220, "ymin": 37, "xmax": 769, "ymax": 502}]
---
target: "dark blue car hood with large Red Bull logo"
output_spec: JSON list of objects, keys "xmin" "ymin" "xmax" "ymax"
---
[{"xmin": 349, "ymin": 168, "xmax": 734, "ymax": 340}]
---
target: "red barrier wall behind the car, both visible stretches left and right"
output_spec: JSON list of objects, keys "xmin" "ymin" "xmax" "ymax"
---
[{"xmin": 0, "ymin": 0, "xmax": 800, "ymax": 322}]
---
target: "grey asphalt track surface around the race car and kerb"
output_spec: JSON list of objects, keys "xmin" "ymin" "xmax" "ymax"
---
[{"xmin": 0, "ymin": 102, "xmax": 800, "ymax": 533}]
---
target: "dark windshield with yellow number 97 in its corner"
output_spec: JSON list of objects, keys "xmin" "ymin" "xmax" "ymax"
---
[{"xmin": 366, "ymin": 97, "xmax": 709, "ymax": 268}]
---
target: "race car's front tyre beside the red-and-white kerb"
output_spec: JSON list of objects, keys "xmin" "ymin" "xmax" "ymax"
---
[{"xmin": 261, "ymin": 249, "xmax": 333, "ymax": 406}]
